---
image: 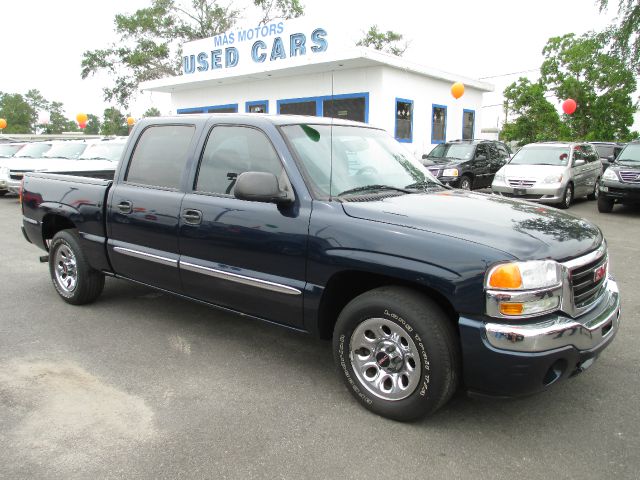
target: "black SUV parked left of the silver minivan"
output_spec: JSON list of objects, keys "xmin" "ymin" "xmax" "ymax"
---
[{"xmin": 422, "ymin": 140, "xmax": 511, "ymax": 190}]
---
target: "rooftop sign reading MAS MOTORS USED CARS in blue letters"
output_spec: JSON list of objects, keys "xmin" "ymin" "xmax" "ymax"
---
[{"xmin": 182, "ymin": 20, "xmax": 329, "ymax": 75}]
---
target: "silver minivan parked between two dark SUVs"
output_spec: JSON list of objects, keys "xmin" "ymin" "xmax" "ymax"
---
[{"xmin": 491, "ymin": 142, "xmax": 602, "ymax": 208}]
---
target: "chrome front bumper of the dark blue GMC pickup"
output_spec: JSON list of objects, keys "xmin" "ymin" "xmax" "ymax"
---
[{"xmin": 485, "ymin": 277, "xmax": 620, "ymax": 352}]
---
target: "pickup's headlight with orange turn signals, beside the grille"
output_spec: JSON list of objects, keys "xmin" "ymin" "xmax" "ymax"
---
[{"xmin": 485, "ymin": 260, "xmax": 562, "ymax": 317}]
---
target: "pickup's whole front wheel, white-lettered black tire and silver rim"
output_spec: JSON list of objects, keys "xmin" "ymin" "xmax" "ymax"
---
[{"xmin": 333, "ymin": 287, "xmax": 460, "ymax": 421}]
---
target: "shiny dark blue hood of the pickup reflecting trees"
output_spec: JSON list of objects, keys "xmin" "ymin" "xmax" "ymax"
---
[{"xmin": 343, "ymin": 190, "xmax": 602, "ymax": 261}]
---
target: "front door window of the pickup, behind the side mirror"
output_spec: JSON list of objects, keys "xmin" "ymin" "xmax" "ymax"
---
[{"xmin": 195, "ymin": 126, "xmax": 283, "ymax": 195}]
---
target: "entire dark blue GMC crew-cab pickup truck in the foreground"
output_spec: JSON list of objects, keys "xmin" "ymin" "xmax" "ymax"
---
[{"xmin": 22, "ymin": 114, "xmax": 620, "ymax": 420}]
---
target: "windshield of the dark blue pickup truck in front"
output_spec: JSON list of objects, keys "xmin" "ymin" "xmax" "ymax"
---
[{"xmin": 282, "ymin": 125, "xmax": 440, "ymax": 197}]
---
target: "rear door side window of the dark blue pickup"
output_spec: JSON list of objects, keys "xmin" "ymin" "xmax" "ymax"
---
[{"xmin": 125, "ymin": 125, "xmax": 196, "ymax": 189}]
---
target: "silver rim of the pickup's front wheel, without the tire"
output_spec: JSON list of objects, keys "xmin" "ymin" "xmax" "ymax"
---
[{"xmin": 349, "ymin": 318, "xmax": 421, "ymax": 401}]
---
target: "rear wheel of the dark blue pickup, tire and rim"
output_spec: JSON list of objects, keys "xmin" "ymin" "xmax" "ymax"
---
[{"xmin": 49, "ymin": 230, "xmax": 104, "ymax": 305}]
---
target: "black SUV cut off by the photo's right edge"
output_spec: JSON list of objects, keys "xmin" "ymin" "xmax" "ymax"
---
[{"xmin": 598, "ymin": 142, "xmax": 640, "ymax": 213}]
